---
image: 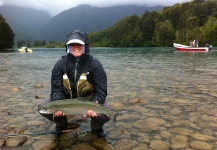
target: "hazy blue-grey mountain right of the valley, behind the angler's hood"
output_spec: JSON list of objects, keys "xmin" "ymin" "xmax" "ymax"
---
[{"xmin": 41, "ymin": 5, "xmax": 163, "ymax": 41}]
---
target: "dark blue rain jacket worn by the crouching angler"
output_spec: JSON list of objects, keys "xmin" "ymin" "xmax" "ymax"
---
[{"xmin": 51, "ymin": 53, "xmax": 107, "ymax": 104}]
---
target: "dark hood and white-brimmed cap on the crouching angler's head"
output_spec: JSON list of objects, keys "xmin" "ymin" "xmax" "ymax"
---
[{"xmin": 65, "ymin": 30, "xmax": 89, "ymax": 55}]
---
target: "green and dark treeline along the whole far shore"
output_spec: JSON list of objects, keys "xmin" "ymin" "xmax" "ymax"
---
[{"xmin": 0, "ymin": 0, "xmax": 217, "ymax": 50}]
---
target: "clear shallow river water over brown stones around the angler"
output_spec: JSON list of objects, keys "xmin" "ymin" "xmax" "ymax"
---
[{"xmin": 0, "ymin": 48, "xmax": 217, "ymax": 150}]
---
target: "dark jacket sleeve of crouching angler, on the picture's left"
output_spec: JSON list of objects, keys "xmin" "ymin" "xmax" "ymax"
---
[{"xmin": 51, "ymin": 59, "xmax": 65, "ymax": 101}]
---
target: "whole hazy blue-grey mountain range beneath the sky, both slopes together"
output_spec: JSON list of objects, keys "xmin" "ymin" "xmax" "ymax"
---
[{"xmin": 0, "ymin": 5, "xmax": 163, "ymax": 42}]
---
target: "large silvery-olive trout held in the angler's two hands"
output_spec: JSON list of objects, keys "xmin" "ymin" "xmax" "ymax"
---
[{"xmin": 39, "ymin": 99, "xmax": 118, "ymax": 122}]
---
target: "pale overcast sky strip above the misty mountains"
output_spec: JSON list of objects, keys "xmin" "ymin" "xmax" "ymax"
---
[{"xmin": 0, "ymin": 0, "xmax": 191, "ymax": 16}]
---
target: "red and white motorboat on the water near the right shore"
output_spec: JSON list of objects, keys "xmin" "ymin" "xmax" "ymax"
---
[{"xmin": 173, "ymin": 43, "xmax": 211, "ymax": 52}]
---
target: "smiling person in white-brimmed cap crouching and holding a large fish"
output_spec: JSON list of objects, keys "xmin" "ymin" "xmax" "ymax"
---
[{"xmin": 37, "ymin": 30, "xmax": 110, "ymax": 138}]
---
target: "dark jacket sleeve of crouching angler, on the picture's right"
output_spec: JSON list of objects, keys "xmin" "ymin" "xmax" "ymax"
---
[{"xmin": 92, "ymin": 59, "xmax": 107, "ymax": 104}]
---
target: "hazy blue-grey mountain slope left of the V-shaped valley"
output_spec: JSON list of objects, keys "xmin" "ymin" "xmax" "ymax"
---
[{"xmin": 0, "ymin": 5, "xmax": 51, "ymax": 41}]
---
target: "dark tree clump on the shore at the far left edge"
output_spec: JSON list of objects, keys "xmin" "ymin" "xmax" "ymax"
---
[{"xmin": 0, "ymin": 15, "xmax": 15, "ymax": 50}]
